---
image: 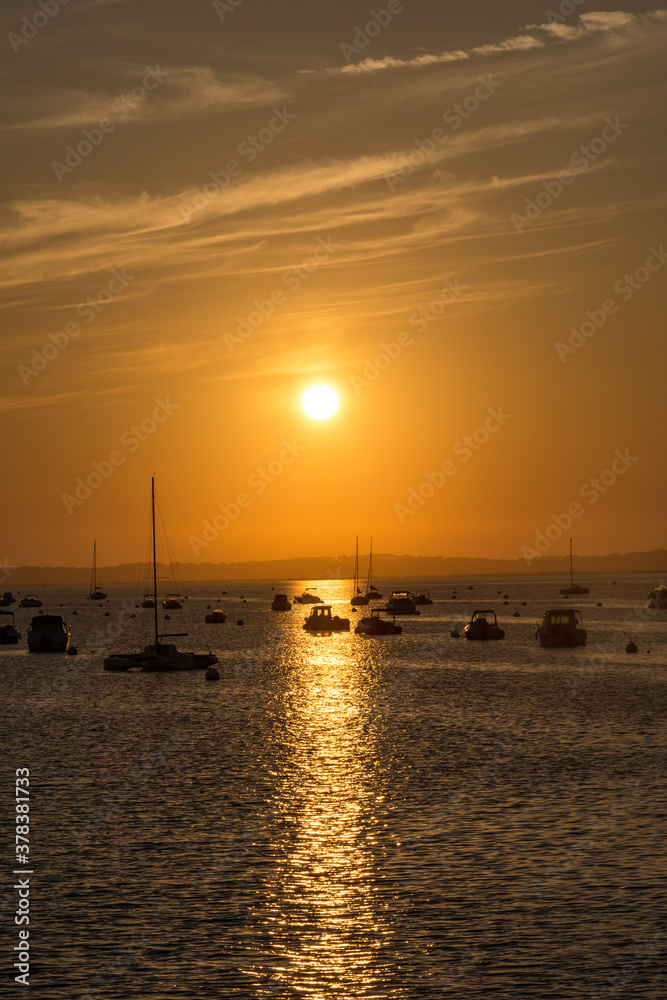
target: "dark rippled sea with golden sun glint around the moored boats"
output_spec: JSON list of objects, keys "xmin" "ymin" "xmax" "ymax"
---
[{"xmin": 0, "ymin": 575, "xmax": 667, "ymax": 1000}]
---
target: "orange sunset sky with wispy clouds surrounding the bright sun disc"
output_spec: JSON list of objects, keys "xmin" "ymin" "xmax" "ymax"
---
[{"xmin": 0, "ymin": 0, "xmax": 667, "ymax": 566}]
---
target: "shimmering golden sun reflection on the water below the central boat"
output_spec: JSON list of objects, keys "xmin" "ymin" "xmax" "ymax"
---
[{"xmin": 253, "ymin": 636, "xmax": 403, "ymax": 1000}]
